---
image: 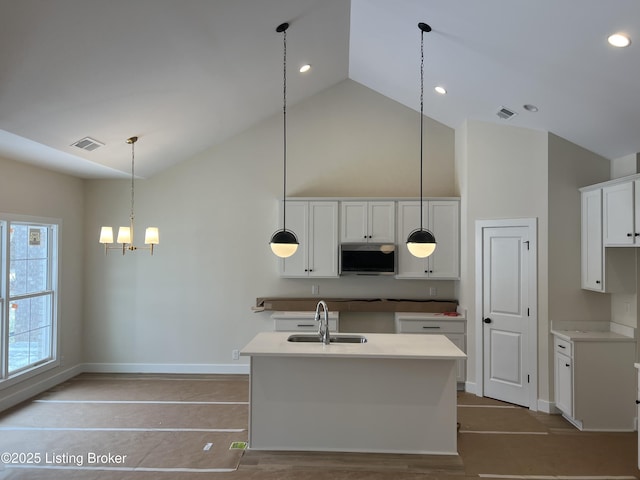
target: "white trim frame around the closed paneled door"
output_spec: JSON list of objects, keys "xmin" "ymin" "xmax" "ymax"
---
[{"xmin": 474, "ymin": 218, "xmax": 538, "ymax": 411}]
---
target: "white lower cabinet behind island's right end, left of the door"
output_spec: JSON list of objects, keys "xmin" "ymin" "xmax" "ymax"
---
[{"xmin": 395, "ymin": 312, "xmax": 467, "ymax": 390}]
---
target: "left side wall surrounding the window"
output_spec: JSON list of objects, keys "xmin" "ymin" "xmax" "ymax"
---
[{"xmin": 0, "ymin": 158, "xmax": 84, "ymax": 410}]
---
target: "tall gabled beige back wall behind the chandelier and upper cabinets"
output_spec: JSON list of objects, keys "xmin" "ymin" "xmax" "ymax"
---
[{"xmin": 85, "ymin": 80, "xmax": 455, "ymax": 371}]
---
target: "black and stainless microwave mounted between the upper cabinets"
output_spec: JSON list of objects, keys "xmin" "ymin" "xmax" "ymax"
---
[{"xmin": 340, "ymin": 243, "xmax": 396, "ymax": 275}]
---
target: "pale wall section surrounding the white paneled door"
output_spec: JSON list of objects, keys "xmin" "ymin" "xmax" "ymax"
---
[{"xmin": 456, "ymin": 120, "xmax": 548, "ymax": 398}]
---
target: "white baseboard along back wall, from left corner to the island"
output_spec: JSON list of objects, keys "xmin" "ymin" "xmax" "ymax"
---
[{"xmin": 83, "ymin": 363, "xmax": 249, "ymax": 375}]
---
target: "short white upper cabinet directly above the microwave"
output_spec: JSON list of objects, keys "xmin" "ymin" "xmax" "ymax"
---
[{"xmin": 340, "ymin": 201, "xmax": 396, "ymax": 243}]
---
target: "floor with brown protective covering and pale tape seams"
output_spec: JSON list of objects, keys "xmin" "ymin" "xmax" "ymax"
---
[{"xmin": 0, "ymin": 374, "xmax": 640, "ymax": 480}]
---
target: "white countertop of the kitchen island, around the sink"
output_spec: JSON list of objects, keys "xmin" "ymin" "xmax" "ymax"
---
[{"xmin": 240, "ymin": 332, "xmax": 467, "ymax": 360}]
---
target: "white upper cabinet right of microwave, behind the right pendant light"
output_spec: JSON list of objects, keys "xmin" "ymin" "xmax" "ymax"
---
[{"xmin": 396, "ymin": 200, "xmax": 460, "ymax": 279}]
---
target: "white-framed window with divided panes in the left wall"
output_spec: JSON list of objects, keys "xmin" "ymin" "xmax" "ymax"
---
[{"xmin": 0, "ymin": 214, "xmax": 58, "ymax": 384}]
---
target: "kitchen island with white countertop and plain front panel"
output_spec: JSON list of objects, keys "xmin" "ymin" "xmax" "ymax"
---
[{"xmin": 240, "ymin": 332, "xmax": 466, "ymax": 455}]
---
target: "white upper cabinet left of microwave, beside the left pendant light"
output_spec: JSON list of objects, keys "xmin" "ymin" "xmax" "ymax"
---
[{"xmin": 281, "ymin": 200, "xmax": 338, "ymax": 278}]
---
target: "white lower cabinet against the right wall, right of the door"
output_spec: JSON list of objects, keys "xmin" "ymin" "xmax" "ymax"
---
[{"xmin": 553, "ymin": 332, "xmax": 636, "ymax": 431}]
